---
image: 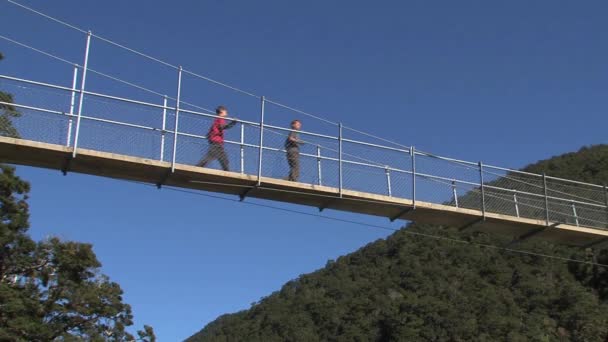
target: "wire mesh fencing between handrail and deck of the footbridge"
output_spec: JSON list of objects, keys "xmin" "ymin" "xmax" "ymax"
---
[{"xmin": 0, "ymin": 77, "xmax": 608, "ymax": 229}]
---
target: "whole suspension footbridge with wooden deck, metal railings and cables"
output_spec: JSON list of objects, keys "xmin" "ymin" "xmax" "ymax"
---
[{"xmin": 0, "ymin": 0, "xmax": 608, "ymax": 246}]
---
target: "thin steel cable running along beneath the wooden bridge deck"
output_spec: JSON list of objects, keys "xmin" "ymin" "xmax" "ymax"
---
[{"xmin": 125, "ymin": 181, "xmax": 608, "ymax": 267}]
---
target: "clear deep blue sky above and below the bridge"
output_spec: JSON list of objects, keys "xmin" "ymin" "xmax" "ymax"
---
[{"xmin": 0, "ymin": 0, "xmax": 608, "ymax": 341}]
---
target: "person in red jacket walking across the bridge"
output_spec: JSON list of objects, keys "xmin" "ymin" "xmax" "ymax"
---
[{"xmin": 196, "ymin": 106, "xmax": 236, "ymax": 171}]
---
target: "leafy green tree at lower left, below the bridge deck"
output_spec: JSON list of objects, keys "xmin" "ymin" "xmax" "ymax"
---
[{"xmin": 0, "ymin": 165, "xmax": 155, "ymax": 342}]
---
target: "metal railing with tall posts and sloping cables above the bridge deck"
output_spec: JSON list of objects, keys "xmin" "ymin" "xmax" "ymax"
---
[{"xmin": 0, "ymin": 0, "xmax": 608, "ymax": 229}]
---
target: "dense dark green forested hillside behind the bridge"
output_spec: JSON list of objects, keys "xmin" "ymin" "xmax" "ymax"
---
[{"xmin": 188, "ymin": 145, "xmax": 608, "ymax": 342}]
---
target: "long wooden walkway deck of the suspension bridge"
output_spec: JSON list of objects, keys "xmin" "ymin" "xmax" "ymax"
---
[{"xmin": 0, "ymin": 137, "xmax": 608, "ymax": 246}]
